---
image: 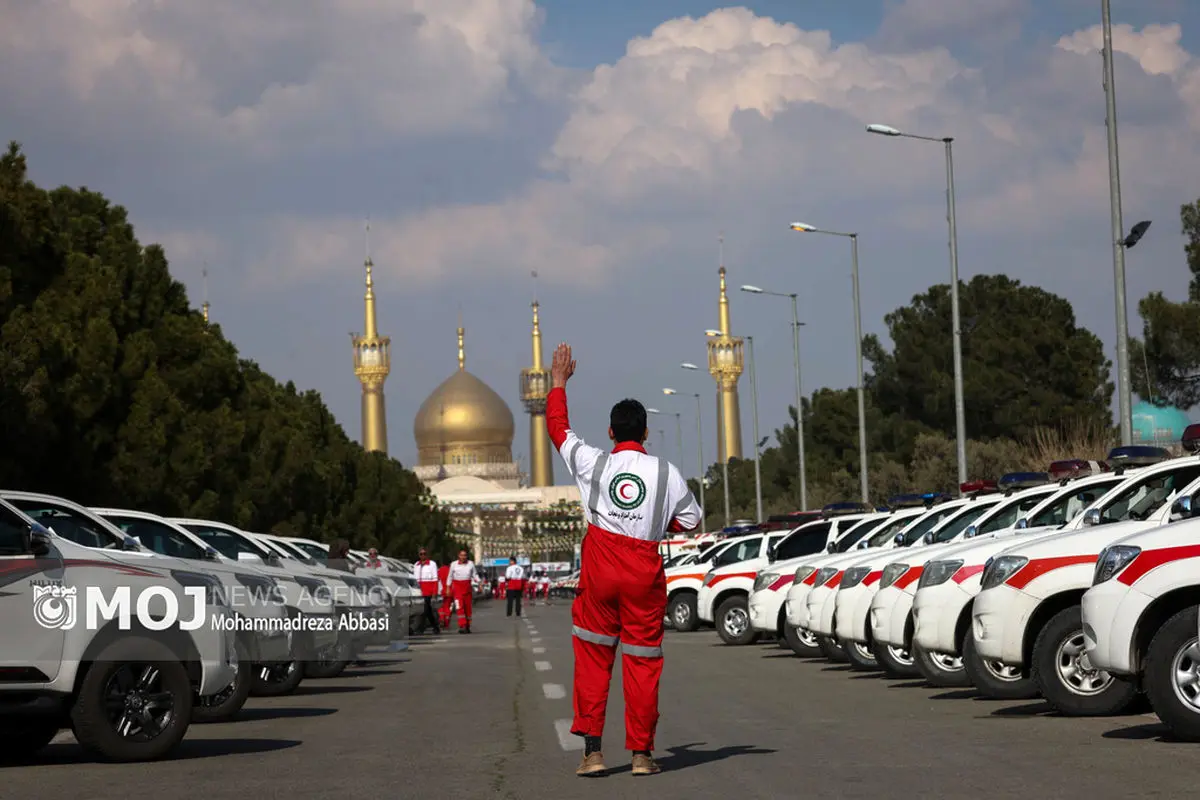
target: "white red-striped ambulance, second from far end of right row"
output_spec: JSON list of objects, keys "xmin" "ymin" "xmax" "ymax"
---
[{"xmin": 696, "ymin": 503, "xmax": 875, "ymax": 644}]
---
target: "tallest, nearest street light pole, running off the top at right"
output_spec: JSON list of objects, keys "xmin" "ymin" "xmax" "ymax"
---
[{"xmin": 1100, "ymin": 0, "xmax": 1133, "ymax": 445}]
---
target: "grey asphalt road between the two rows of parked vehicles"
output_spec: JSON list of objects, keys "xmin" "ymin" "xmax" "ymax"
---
[{"xmin": 7, "ymin": 601, "xmax": 1200, "ymax": 800}]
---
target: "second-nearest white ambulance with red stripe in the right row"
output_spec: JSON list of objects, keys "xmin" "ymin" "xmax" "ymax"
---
[{"xmin": 971, "ymin": 446, "xmax": 1200, "ymax": 716}]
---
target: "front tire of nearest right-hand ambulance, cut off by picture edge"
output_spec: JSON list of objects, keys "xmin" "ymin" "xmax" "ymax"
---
[{"xmin": 1142, "ymin": 606, "xmax": 1200, "ymax": 741}]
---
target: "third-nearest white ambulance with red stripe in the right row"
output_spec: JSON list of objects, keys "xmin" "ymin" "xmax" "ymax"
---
[{"xmin": 916, "ymin": 459, "xmax": 1123, "ymax": 699}]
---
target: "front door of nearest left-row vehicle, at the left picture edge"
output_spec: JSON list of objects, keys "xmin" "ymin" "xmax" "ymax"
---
[{"xmin": 0, "ymin": 503, "xmax": 64, "ymax": 684}]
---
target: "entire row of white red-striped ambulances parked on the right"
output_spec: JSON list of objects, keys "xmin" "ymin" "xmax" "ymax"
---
[{"xmin": 666, "ymin": 441, "xmax": 1200, "ymax": 741}]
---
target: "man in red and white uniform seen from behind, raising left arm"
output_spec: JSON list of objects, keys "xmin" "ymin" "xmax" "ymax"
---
[{"xmin": 546, "ymin": 344, "xmax": 701, "ymax": 776}]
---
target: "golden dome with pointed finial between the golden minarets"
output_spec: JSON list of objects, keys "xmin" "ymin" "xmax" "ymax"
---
[{"xmin": 413, "ymin": 327, "xmax": 516, "ymax": 467}]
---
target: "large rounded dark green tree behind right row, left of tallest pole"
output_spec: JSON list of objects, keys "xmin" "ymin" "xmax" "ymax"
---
[{"xmin": 864, "ymin": 275, "xmax": 1112, "ymax": 443}]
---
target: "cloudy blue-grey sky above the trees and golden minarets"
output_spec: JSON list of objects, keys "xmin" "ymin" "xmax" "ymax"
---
[{"xmin": 0, "ymin": 0, "xmax": 1200, "ymax": 482}]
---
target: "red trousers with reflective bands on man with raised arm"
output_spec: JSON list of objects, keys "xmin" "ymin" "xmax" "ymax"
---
[{"xmin": 571, "ymin": 525, "xmax": 667, "ymax": 750}]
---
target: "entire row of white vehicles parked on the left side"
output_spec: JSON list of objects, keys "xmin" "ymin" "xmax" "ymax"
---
[{"xmin": 0, "ymin": 489, "xmax": 421, "ymax": 762}]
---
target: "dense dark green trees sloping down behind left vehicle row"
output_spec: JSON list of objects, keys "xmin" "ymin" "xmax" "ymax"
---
[{"xmin": 0, "ymin": 144, "xmax": 455, "ymax": 558}]
